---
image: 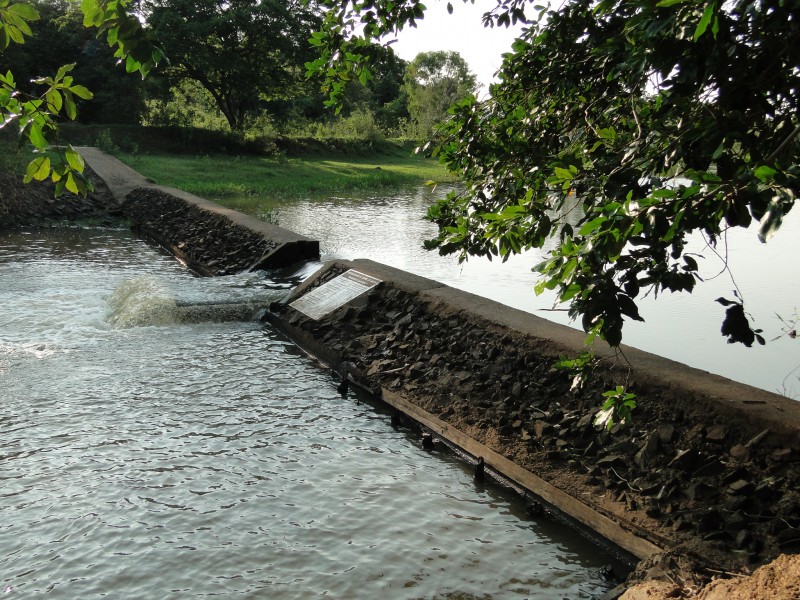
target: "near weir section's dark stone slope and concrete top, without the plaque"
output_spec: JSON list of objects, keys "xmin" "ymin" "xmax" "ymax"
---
[{"xmin": 271, "ymin": 261, "xmax": 800, "ymax": 576}]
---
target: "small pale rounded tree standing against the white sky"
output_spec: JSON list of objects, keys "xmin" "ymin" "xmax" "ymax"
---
[{"xmin": 403, "ymin": 51, "xmax": 477, "ymax": 138}]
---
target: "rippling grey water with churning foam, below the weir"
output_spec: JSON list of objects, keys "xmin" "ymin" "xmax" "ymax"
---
[{"xmin": 0, "ymin": 227, "xmax": 611, "ymax": 599}]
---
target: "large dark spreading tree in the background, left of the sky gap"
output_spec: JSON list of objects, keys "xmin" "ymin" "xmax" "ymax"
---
[{"xmin": 147, "ymin": 0, "xmax": 320, "ymax": 131}]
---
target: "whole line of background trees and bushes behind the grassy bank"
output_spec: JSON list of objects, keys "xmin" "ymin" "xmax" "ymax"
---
[{"xmin": 0, "ymin": 0, "xmax": 475, "ymax": 143}]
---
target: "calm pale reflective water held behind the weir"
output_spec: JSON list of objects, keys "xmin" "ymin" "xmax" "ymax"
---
[{"xmin": 225, "ymin": 188, "xmax": 800, "ymax": 398}]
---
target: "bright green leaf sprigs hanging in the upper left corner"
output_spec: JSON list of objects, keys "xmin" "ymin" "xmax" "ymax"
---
[{"xmin": 0, "ymin": 0, "xmax": 162, "ymax": 194}]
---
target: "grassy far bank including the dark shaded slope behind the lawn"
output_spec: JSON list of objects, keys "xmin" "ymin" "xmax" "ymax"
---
[{"xmin": 0, "ymin": 125, "xmax": 455, "ymax": 206}]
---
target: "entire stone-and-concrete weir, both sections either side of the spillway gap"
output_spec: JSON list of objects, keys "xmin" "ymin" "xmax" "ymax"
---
[{"xmin": 72, "ymin": 148, "xmax": 800, "ymax": 583}]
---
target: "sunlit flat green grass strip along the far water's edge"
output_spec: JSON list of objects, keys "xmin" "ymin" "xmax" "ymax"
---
[{"xmin": 117, "ymin": 147, "xmax": 455, "ymax": 207}]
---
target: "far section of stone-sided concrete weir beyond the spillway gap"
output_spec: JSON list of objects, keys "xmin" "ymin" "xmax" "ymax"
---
[{"xmin": 78, "ymin": 147, "xmax": 319, "ymax": 276}]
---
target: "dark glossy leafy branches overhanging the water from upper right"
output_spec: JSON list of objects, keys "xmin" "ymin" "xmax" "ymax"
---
[{"xmin": 313, "ymin": 0, "xmax": 800, "ymax": 346}]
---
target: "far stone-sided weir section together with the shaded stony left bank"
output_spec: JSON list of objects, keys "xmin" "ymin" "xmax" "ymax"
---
[{"xmin": 0, "ymin": 148, "xmax": 319, "ymax": 275}]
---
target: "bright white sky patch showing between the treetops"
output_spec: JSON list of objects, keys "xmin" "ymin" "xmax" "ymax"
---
[{"xmin": 383, "ymin": 0, "xmax": 521, "ymax": 90}]
